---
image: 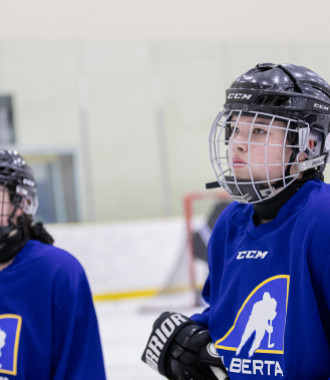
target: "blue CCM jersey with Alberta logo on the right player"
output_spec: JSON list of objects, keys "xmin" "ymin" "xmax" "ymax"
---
[{"xmin": 192, "ymin": 180, "xmax": 330, "ymax": 380}]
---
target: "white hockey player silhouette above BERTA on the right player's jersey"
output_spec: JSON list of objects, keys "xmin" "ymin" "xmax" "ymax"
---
[{"xmin": 236, "ymin": 292, "xmax": 277, "ymax": 357}]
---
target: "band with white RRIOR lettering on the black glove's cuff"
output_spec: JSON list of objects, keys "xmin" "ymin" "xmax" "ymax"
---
[{"xmin": 145, "ymin": 314, "xmax": 188, "ymax": 369}]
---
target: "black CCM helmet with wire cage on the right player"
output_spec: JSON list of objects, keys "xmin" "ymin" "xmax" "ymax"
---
[{"xmin": 207, "ymin": 63, "xmax": 330, "ymax": 203}]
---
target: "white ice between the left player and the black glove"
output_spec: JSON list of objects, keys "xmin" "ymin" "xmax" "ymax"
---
[{"xmin": 95, "ymin": 294, "xmax": 202, "ymax": 380}]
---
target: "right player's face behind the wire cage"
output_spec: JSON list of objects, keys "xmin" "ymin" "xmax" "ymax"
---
[{"xmin": 228, "ymin": 116, "xmax": 292, "ymax": 181}]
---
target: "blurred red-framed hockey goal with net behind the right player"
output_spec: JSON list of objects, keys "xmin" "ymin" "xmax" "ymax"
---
[{"xmin": 143, "ymin": 189, "xmax": 231, "ymax": 311}]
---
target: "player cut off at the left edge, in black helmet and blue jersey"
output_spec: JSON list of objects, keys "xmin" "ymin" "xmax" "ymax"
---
[{"xmin": 0, "ymin": 150, "xmax": 106, "ymax": 380}]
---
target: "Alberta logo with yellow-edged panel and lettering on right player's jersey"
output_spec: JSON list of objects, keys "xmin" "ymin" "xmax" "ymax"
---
[{"xmin": 215, "ymin": 275, "xmax": 290, "ymax": 376}]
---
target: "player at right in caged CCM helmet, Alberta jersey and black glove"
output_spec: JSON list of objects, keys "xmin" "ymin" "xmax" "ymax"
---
[{"xmin": 142, "ymin": 63, "xmax": 330, "ymax": 380}]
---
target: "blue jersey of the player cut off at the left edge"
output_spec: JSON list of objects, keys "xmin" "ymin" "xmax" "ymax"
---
[{"xmin": 0, "ymin": 240, "xmax": 105, "ymax": 380}]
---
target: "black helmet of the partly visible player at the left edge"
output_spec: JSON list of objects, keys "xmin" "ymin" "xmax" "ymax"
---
[{"xmin": 0, "ymin": 149, "xmax": 38, "ymax": 236}]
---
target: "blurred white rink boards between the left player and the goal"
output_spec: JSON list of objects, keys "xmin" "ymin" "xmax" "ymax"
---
[{"xmin": 46, "ymin": 218, "xmax": 205, "ymax": 296}]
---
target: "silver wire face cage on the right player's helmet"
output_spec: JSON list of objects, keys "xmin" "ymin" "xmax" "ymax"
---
[{"xmin": 209, "ymin": 109, "xmax": 312, "ymax": 203}]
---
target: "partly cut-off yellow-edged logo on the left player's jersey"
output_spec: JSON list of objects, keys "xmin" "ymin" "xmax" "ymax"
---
[{"xmin": 0, "ymin": 314, "xmax": 22, "ymax": 375}]
